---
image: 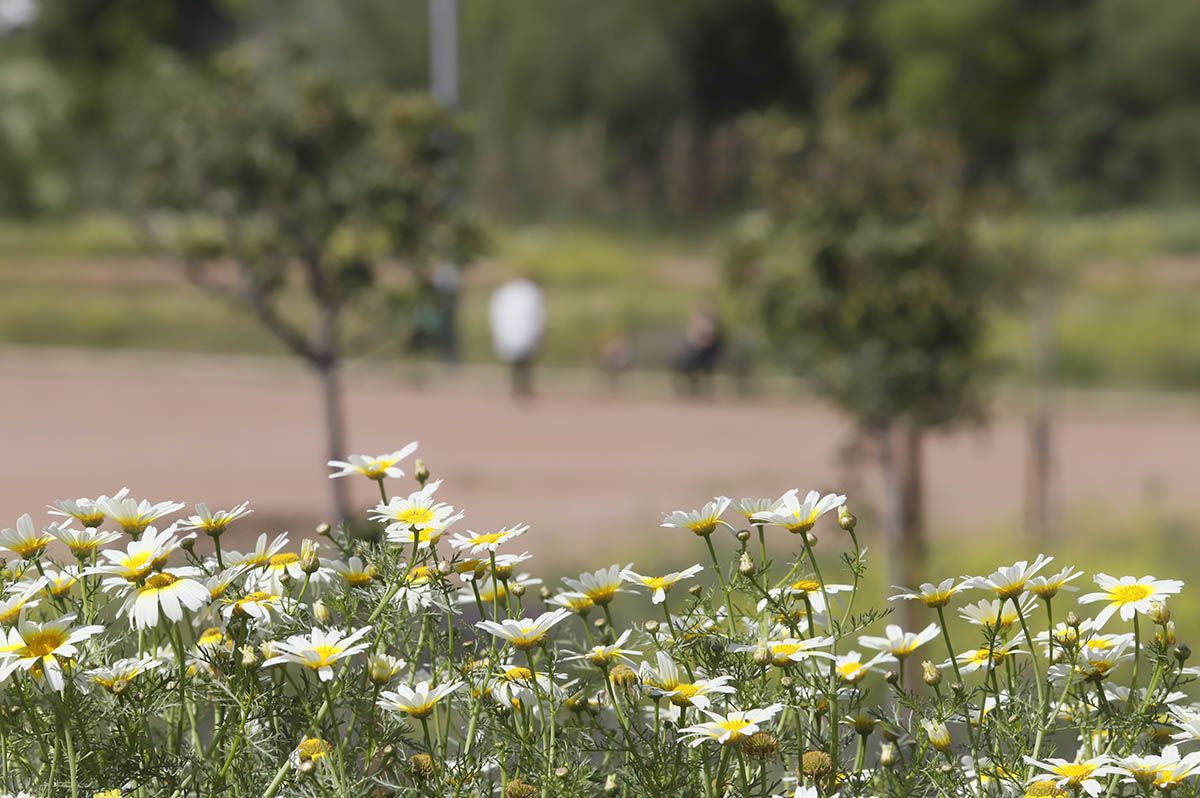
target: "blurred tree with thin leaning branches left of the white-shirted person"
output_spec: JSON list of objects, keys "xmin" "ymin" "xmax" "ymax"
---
[{"xmin": 124, "ymin": 55, "xmax": 478, "ymax": 518}]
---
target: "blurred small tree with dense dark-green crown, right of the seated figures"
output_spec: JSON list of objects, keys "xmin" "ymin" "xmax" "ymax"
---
[{"xmin": 758, "ymin": 114, "xmax": 1001, "ymax": 628}]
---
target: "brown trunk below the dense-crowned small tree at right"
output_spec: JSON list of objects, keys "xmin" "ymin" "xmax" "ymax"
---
[{"xmin": 876, "ymin": 421, "xmax": 929, "ymax": 686}]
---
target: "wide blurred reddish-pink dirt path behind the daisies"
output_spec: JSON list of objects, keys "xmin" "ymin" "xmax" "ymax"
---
[{"xmin": 0, "ymin": 350, "xmax": 1200, "ymax": 560}]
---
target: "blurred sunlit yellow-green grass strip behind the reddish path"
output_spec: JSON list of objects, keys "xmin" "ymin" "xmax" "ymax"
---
[{"xmin": 7, "ymin": 209, "xmax": 1200, "ymax": 390}]
